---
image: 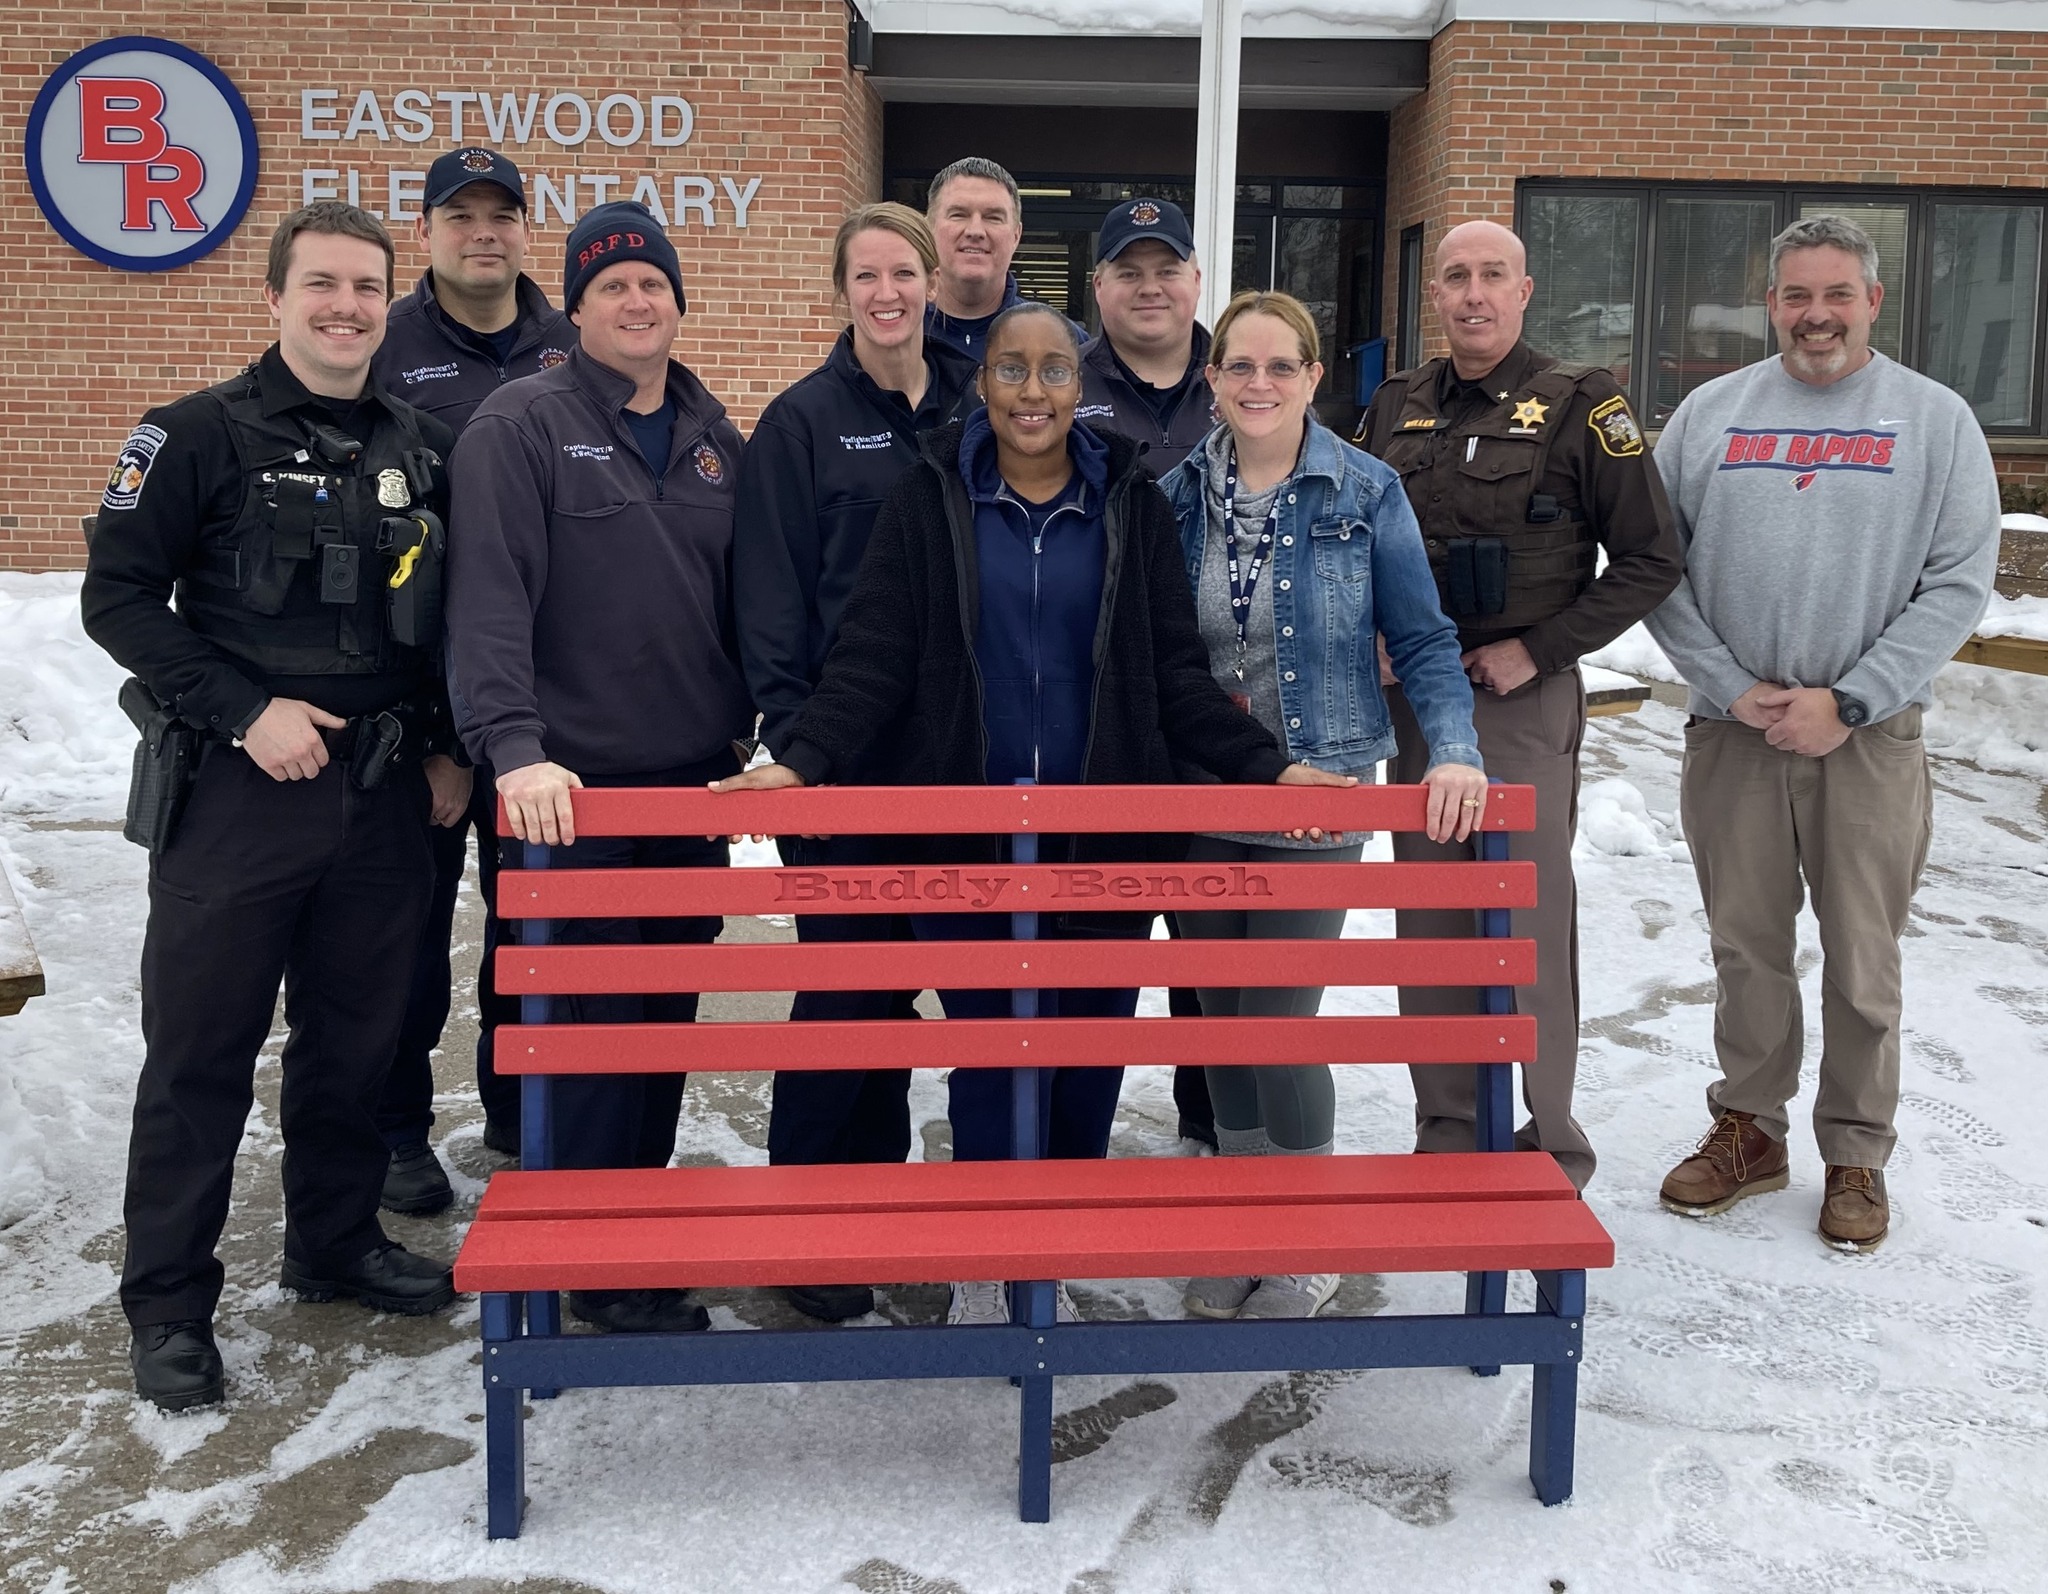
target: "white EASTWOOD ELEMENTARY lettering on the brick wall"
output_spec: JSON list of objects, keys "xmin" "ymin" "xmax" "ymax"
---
[{"xmin": 299, "ymin": 88, "xmax": 762, "ymax": 229}]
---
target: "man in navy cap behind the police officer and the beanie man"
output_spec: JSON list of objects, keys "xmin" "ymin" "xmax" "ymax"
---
[{"xmin": 371, "ymin": 145, "xmax": 575, "ymax": 1213}]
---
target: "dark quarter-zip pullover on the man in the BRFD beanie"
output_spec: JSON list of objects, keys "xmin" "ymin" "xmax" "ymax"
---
[{"xmin": 449, "ymin": 348, "xmax": 754, "ymax": 774}]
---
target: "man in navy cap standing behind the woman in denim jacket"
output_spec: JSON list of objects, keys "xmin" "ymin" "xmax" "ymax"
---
[{"xmin": 1073, "ymin": 195, "xmax": 1217, "ymax": 1145}]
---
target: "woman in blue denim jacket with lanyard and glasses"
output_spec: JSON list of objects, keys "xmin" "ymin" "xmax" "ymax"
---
[{"xmin": 1161, "ymin": 293, "xmax": 1487, "ymax": 1317}]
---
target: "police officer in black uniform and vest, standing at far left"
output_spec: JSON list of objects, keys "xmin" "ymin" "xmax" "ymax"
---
[{"xmin": 82, "ymin": 203, "xmax": 455, "ymax": 1410}]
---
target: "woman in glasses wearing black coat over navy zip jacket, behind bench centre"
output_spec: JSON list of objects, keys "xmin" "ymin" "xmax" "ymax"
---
[{"xmin": 713, "ymin": 303, "xmax": 1352, "ymax": 1322}]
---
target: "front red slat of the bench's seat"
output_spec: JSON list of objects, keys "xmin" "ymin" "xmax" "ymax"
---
[{"xmin": 455, "ymin": 1201, "xmax": 1614, "ymax": 1291}]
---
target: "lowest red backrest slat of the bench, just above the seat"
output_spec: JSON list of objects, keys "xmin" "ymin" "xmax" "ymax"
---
[{"xmin": 492, "ymin": 1014, "xmax": 1536, "ymax": 1074}]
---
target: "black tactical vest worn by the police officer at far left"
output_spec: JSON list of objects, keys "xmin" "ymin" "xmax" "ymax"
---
[{"xmin": 178, "ymin": 365, "xmax": 440, "ymax": 676}]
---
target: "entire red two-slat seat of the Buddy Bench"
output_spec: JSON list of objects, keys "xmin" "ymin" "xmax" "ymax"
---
[{"xmin": 455, "ymin": 1151, "xmax": 1614, "ymax": 1293}]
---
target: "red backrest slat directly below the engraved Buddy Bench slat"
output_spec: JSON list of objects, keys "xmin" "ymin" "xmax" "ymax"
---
[{"xmin": 498, "ymin": 938, "xmax": 1536, "ymax": 996}]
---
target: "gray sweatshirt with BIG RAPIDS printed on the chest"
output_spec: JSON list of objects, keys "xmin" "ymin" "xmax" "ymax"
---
[{"xmin": 1649, "ymin": 354, "xmax": 1999, "ymax": 721}]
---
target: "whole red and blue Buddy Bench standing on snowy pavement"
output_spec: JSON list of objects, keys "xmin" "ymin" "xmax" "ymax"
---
[{"xmin": 455, "ymin": 787, "xmax": 1614, "ymax": 1539}]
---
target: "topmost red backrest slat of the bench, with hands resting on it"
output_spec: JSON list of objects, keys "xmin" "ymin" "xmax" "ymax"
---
[{"xmin": 498, "ymin": 785, "xmax": 1536, "ymax": 836}]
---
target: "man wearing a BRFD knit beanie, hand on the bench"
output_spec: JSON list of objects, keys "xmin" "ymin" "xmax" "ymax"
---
[{"xmin": 449, "ymin": 203, "xmax": 754, "ymax": 1332}]
